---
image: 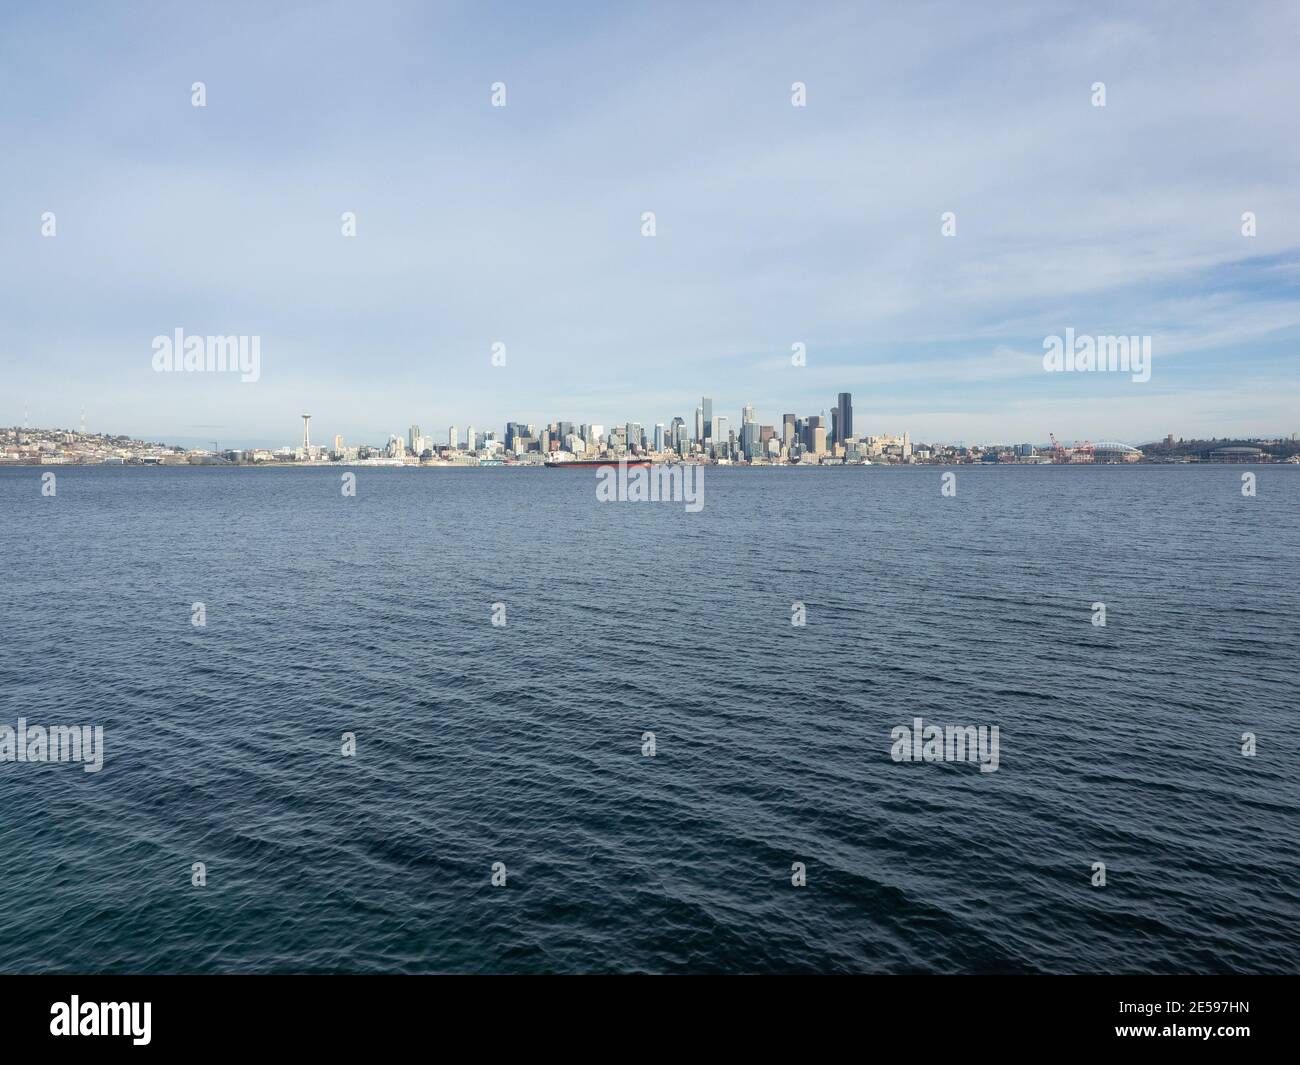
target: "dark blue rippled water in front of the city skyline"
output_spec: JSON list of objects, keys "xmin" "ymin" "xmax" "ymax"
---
[{"xmin": 0, "ymin": 467, "xmax": 1300, "ymax": 973}]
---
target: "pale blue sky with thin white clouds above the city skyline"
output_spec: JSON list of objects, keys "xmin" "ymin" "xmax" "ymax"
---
[{"xmin": 0, "ymin": 0, "xmax": 1300, "ymax": 447}]
